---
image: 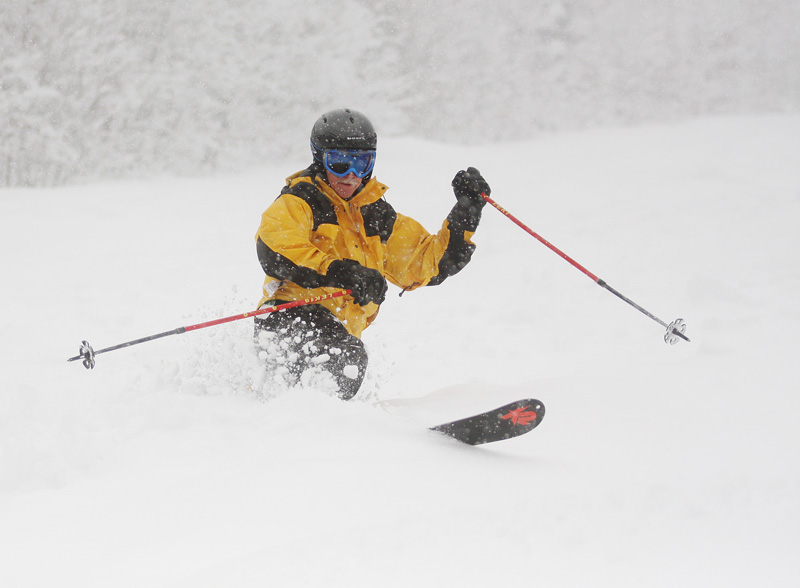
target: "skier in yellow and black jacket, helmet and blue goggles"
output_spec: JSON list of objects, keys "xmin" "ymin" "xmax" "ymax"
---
[{"xmin": 255, "ymin": 108, "xmax": 491, "ymax": 400}]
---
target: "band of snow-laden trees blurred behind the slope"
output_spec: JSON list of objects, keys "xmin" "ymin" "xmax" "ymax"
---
[{"xmin": 0, "ymin": 0, "xmax": 800, "ymax": 186}]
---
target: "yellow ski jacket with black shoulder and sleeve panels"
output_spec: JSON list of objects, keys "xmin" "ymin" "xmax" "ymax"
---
[{"xmin": 256, "ymin": 166, "xmax": 480, "ymax": 337}]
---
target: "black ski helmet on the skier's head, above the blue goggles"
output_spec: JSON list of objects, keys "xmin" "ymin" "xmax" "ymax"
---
[{"xmin": 311, "ymin": 108, "xmax": 378, "ymax": 161}]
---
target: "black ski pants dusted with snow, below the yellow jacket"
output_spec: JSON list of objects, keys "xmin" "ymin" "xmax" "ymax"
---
[{"xmin": 254, "ymin": 300, "xmax": 368, "ymax": 400}]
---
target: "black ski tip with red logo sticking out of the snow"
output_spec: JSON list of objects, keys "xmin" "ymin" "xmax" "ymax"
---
[{"xmin": 430, "ymin": 398, "xmax": 544, "ymax": 445}]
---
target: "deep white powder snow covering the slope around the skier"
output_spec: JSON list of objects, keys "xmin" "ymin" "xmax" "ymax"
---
[{"xmin": 0, "ymin": 115, "xmax": 800, "ymax": 588}]
